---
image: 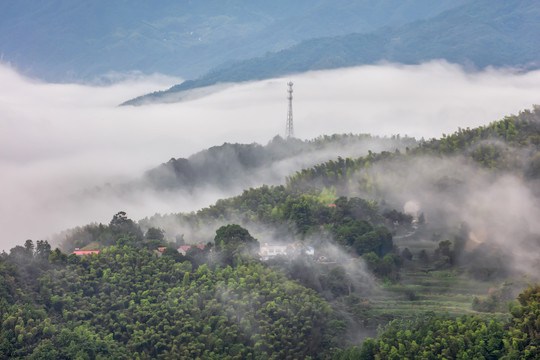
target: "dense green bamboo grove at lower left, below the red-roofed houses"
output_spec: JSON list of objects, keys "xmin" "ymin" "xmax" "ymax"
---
[{"xmin": 0, "ymin": 238, "xmax": 336, "ymax": 359}]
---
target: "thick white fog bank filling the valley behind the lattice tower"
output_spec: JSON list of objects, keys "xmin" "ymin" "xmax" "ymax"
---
[{"xmin": 0, "ymin": 61, "xmax": 540, "ymax": 251}]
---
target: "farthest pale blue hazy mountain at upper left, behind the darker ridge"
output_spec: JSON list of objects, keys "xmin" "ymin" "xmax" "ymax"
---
[{"xmin": 0, "ymin": 0, "xmax": 463, "ymax": 82}]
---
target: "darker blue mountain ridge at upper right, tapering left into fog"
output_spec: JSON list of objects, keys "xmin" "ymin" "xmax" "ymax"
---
[{"xmin": 124, "ymin": 0, "xmax": 540, "ymax": 105}]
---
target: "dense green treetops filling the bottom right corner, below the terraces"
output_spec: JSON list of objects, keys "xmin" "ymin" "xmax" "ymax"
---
[{"xmin": 334, "ymin": 284, "xmax": 540, "ymax": 360}]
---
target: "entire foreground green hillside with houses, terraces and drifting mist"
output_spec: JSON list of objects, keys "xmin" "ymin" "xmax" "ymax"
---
[{"xmin": 0, "ymin": 106, "xmax": 540, "ymax": 359}]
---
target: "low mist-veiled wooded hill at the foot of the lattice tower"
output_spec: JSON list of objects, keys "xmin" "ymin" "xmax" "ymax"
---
[{"xmin": 142, "ymin": 134, "xmax": 417, "ymax": 192}]
